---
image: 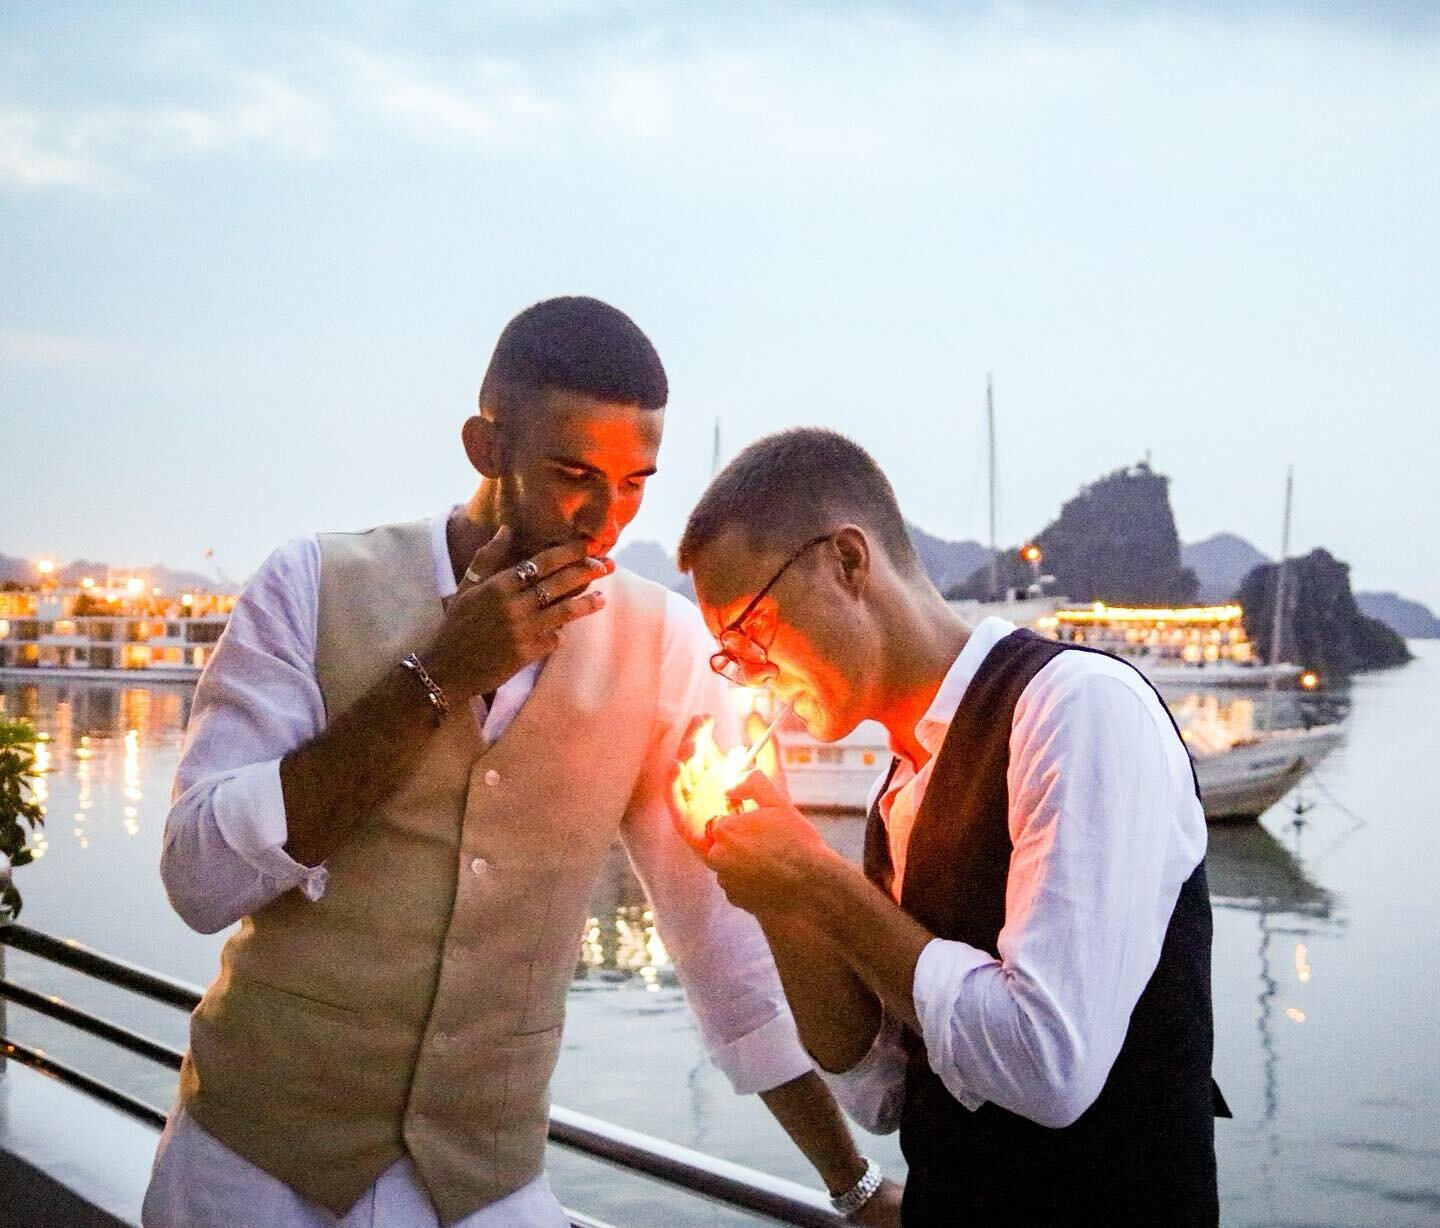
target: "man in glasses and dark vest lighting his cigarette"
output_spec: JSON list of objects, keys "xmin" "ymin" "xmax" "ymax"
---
[{"xmin": 680, "ymin": 429, "xmax": 1225, "ymax": 1225}]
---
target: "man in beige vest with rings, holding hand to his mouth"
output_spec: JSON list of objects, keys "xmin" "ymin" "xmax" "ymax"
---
[{"xmin": 144, "ymin": 298, "xmax": 894, "ymax": 1228}]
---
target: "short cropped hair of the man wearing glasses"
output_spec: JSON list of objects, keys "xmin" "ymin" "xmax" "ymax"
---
[{"xmin": 677, "ymin": 426, "xmax": 920, "ymax": 574}]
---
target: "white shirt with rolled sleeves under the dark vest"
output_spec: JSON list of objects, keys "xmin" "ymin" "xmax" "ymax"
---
[{"xmin": 827, "ymin": 618, "xmax": 1205, "ymax": 1133}]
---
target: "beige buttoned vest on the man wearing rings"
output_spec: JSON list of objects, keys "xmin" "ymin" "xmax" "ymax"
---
[{"xmin": 180, "ymin": 523, "xmax": 665, "ymax": 1224}]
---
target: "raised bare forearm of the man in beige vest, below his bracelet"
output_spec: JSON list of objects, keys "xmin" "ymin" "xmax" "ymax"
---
[{"xmin": 279, "ymin": 665, "xmax": 437, "ymax": 865}]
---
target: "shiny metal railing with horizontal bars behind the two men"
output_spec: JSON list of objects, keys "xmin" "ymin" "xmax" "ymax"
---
[{"xmin": 0, "ymin": 924, "xmax": 845, "ymax": 1228}]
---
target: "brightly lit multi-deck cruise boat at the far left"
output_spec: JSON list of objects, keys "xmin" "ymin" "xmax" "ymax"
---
[{"xmin": 0, "ymin": 576, "xmax": 236, "ymax": 681}]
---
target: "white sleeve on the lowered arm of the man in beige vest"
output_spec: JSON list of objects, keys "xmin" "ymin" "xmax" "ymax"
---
[{"xmin": 622, "ymin": 593, "xmax": 814, "ymax": 1094}]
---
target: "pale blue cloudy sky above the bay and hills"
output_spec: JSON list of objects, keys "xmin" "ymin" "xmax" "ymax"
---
[{"xmin": 0, "ymin": 0, "xmax": 1440, "ymax": 608}]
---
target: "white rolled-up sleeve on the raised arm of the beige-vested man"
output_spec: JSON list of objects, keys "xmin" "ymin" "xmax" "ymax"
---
[{"xmin": 160, "ymin": 537, "xmax": 325, "ymax": 933}]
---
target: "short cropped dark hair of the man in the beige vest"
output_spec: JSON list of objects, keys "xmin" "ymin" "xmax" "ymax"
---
[{"xmin": 480, "ymin": 295, "xmax": 670, "ymax": 415}]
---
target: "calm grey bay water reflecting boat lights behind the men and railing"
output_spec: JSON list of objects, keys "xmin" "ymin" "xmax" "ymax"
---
[{"xmin": 0, "ymin": 642, "xmax": 1440, "ymax": 1228}]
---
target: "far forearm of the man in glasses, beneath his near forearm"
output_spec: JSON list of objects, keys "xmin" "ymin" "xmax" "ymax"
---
[{"xmin": 759, "ymin": 914, "xmax": 883, "ymax": 1073}]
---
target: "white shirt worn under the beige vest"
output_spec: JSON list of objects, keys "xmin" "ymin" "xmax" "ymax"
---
[{"xmin": 144, "ymin": 514, "xmax": 812, "ymax": 1228}]
